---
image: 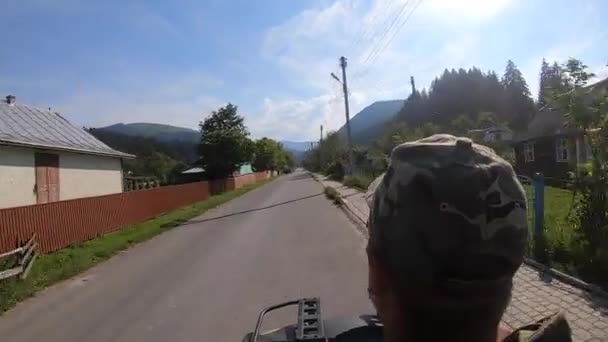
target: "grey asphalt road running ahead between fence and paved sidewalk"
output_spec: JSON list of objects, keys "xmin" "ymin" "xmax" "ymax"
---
[{"xmin": 0, "ymin": 173, "xmax": 371, "ymax": 342}]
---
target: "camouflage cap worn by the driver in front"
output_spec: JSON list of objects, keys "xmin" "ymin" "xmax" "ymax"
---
[{"xmin": 366, "ymin": 134, "xmax": 528, "ymax": 291}]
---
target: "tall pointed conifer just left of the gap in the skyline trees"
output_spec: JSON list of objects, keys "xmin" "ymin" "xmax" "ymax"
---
[{"xmin": 502, "ymin": 60, "xmax": 534, "ymax": 131}]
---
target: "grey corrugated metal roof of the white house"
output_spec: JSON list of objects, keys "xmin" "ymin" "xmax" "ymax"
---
[{"xmin": 0, "ymin": 100, "xmax": 135, "ymax": 158}]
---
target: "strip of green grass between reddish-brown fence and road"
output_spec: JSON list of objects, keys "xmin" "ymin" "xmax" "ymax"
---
[{"xmin": 0, "ymin": 180, "xmax": 269, "ymax": 314}]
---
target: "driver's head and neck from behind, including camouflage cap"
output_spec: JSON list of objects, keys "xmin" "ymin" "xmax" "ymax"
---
[{"xmin": 367, "ymin": 135, "xmax": 528, "ymax": 341}]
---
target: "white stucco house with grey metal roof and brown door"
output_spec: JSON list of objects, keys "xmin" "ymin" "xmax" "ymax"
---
[{"xmin": 0, "ymin": 95, "xmax": 135, "ymax": 208}]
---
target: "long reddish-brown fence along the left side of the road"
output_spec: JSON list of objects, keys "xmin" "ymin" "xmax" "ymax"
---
[{"xmin": 0, "ymin": 172, "xmax": 268, "ymax": 253}]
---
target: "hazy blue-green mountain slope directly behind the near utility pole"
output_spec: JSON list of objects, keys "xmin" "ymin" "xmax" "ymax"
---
[{"xmin": 338, "ymin": 100, "xmax": 405, "ymax": 145}]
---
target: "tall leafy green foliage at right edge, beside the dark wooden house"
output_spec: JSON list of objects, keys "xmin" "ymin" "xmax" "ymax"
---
[{"xmin": 549, "ymin": 58, "xmax": 608, "ymax": 284}]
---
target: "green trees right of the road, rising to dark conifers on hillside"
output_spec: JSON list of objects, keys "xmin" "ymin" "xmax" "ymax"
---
[{"xmin": 303, "ymin": 59, "xmax": 604, "ymax": 185}]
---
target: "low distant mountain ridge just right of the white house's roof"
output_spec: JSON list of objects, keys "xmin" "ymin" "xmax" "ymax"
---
[{"xmin": 97, "ymin": 122, "xmax": 201, "ymax": 143}]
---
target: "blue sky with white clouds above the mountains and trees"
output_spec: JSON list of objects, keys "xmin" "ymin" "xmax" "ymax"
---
[{"xmin": 0, "ymin": 0, "xmax": 608, "ymax": 140}]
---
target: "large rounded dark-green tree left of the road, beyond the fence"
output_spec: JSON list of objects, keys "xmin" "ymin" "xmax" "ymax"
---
[{"xmin": 199, "ymin": 103, "xmax": 255, "ymax": 179}]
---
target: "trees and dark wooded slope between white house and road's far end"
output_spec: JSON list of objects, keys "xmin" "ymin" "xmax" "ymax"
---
[{"xmin": 87, "ymin": 104, "xmax": 296, "ymax": 184}]
